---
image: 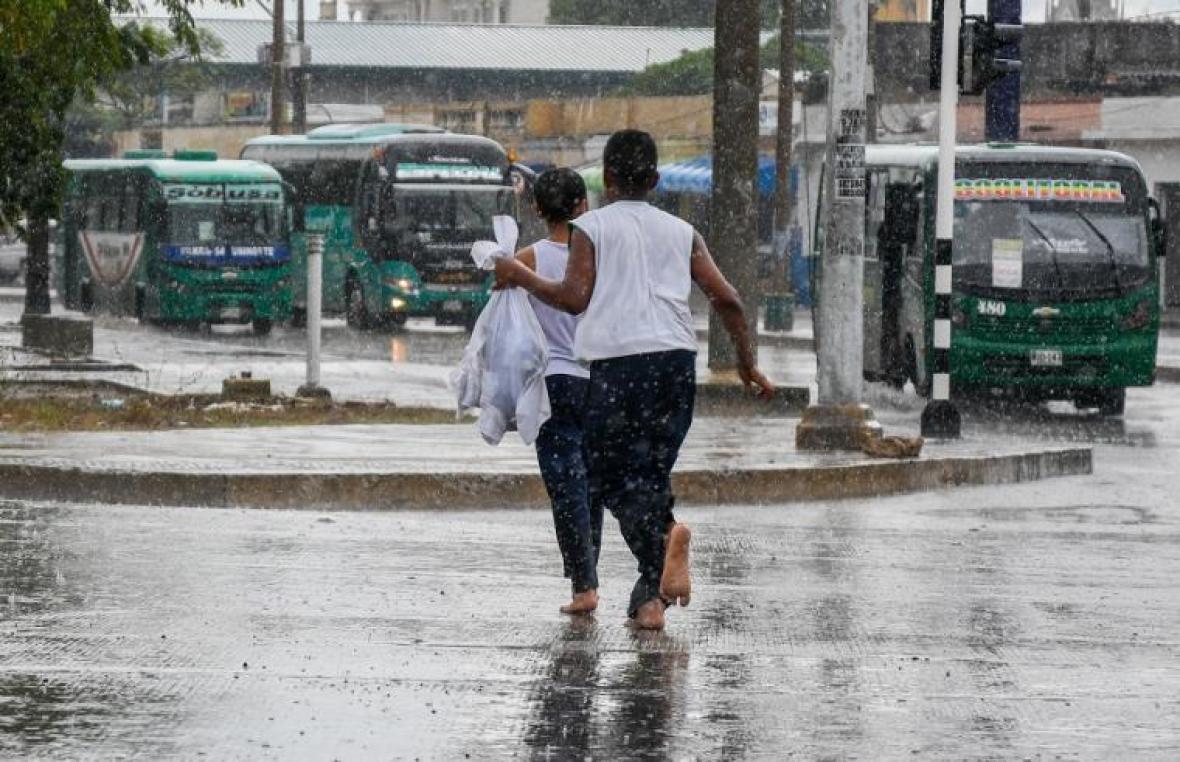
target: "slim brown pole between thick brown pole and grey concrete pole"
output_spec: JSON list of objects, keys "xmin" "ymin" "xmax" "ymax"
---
[{"xmin": 766, "ymin": 0, "xmax": 795, "ymax": 330}]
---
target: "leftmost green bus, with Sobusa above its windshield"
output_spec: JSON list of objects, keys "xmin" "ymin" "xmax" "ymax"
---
[{"xmin": 61, "ymin": 151, "xmax": 291, "ymax": 334}]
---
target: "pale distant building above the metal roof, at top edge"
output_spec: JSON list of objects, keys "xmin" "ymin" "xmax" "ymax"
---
[{"xmin": 337, "ymin": 0, "xmax": 549, "ymax": 24}]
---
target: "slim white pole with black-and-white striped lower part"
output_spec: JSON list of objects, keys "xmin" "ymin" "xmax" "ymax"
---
[{"xmin": 922, "ymin": 0, "xmax": 963, "ymax": 439}]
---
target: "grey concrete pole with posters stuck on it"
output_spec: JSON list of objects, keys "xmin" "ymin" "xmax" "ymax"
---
[{"xmin": 795, "ymin": 0, "xmax": 880, "ymax": 449}]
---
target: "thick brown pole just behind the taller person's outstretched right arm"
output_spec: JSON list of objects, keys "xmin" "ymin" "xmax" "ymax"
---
[{"xmin": 709, "ymin": 0, "xmax": 762, "ymax": 370}]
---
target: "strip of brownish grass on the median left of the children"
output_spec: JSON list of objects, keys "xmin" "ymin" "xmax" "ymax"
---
[{"xmin": 0, "ymin": 383, "xmax": 472, "ymax": 432}]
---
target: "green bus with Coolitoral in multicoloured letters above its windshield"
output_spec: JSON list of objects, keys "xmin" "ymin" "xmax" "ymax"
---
[{"xmin": 835, "ymin": 144, "xmax": 1163, "ymax": 415}]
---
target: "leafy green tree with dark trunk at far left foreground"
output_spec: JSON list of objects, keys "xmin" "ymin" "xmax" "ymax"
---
[{"xmin": 0, "ymin": 0, "xmax": 244, "ymax": 314}]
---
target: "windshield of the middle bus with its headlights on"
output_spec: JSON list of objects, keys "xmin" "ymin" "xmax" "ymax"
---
[{"xmin": 391, "ymin": 185, "xmax": 512, "ymax": 235}]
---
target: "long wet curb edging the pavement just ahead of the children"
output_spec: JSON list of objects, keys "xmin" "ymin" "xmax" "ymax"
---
[{"xmin": 0, "ymin": 448, "xmax": 1093, "ymax": 511}]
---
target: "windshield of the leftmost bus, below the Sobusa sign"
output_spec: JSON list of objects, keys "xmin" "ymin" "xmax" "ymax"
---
[{"xmin": 168, "ymin": 203, "xmax": 283, "ymax": 247}]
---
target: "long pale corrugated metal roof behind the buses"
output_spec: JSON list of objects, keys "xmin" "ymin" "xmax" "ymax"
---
[{"xmin": 145, "ymin": 19, "xmax": 713, "ymax": 73}]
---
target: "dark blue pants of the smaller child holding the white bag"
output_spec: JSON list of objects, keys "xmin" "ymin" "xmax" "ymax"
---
[{"xmin": 537, "ymin": 375, "xmax": 602, "ymax": 592}]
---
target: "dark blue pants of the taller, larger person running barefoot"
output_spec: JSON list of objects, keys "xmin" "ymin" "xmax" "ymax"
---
[{"xmin": 585, "ymin": 350, "xmax": 696, "ymax": 617}]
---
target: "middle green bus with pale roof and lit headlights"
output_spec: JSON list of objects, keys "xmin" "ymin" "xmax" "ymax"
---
[{"xmin": 242, "ymin": 124, "xmax": 519, "ymax": 328}]
